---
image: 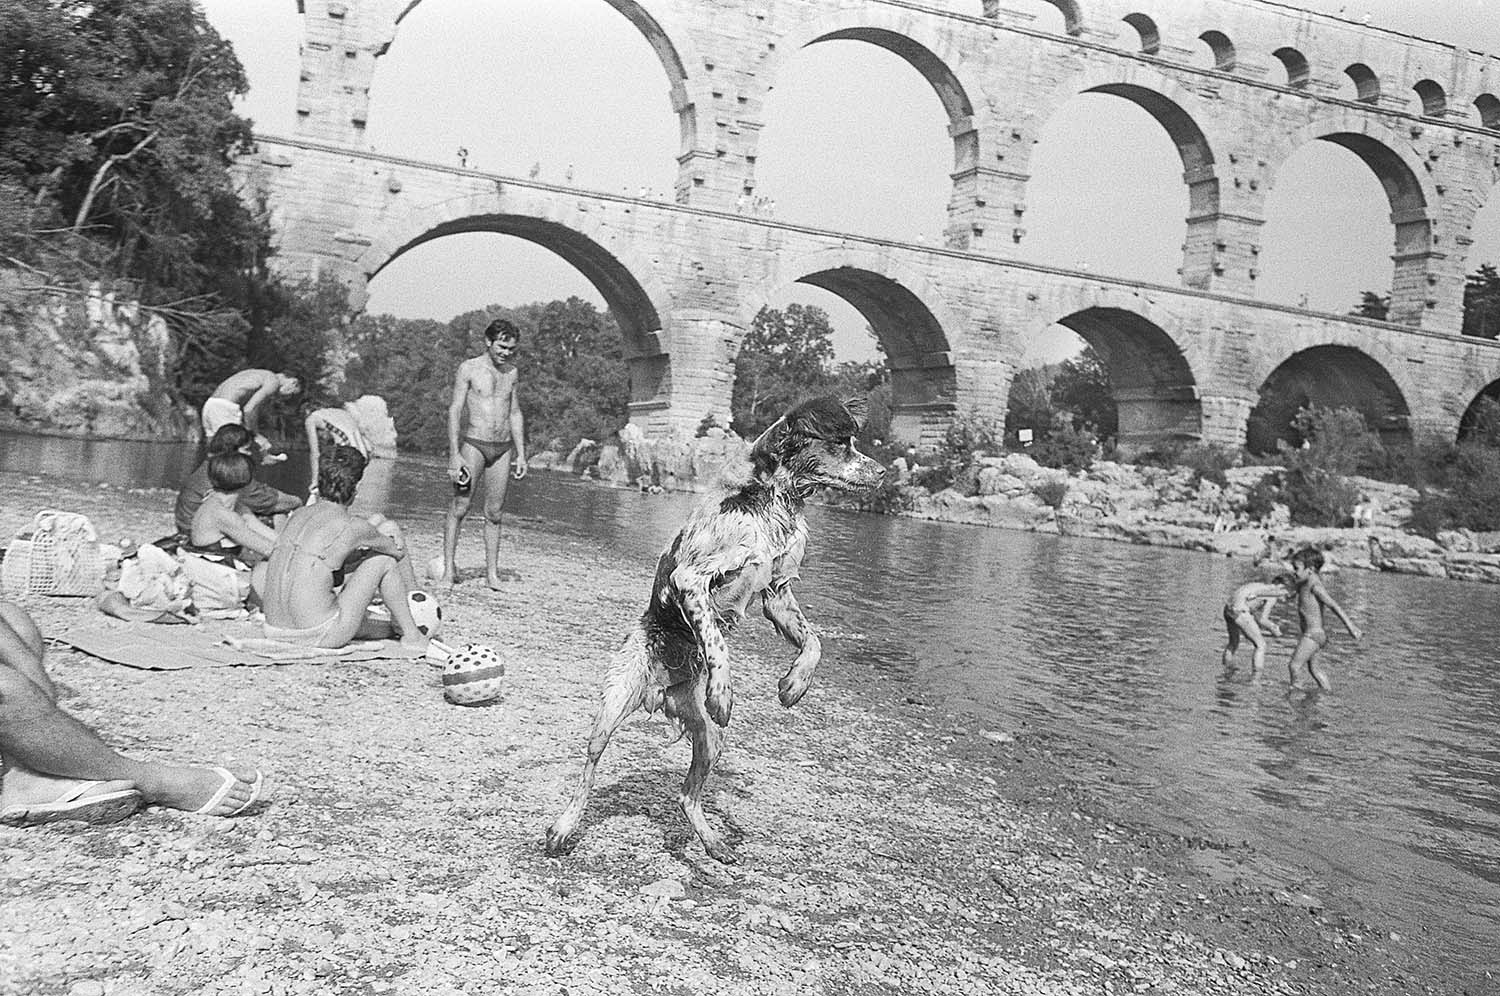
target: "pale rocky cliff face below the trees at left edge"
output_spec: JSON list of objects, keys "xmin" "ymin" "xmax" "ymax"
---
[{"xmin": 0, "ymin": 272, "xmax": 197, "ymax": 440}]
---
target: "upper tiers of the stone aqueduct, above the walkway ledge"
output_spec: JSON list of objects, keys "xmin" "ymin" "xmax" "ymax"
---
[{"xmin": 292, "ymin": 0, "xmax": 1500, "ymax": 339}]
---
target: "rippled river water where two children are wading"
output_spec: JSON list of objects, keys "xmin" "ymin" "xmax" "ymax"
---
[{"xmin": 0, "ymin": 434, "xmax": 1500, "ymax": 975}]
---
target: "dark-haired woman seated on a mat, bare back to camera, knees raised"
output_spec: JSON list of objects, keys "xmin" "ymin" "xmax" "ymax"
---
[{"xmin": 263, "ymin": 446, "xmax": 428, "ymax": 650}]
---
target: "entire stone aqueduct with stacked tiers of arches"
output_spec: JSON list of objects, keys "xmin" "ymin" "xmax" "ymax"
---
[{"xmin": 248, "ymin": 0, "xmax": 1500, "ymax": 446}]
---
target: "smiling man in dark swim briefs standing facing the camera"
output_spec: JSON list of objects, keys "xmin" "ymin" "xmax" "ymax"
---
[{"xmin": 438, "ymin": 318, "xmax": 527, "ymax": 590}]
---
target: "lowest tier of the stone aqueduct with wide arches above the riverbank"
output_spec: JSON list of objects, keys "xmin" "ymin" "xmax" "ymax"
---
[{"xmin": 242, "ymin": 137, "xmax": 1500, "ymax": 447}]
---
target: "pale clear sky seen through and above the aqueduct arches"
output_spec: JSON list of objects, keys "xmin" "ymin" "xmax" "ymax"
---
[{"xmin": 201, "ymin": 0, "xmax": 1500, "ymax": 366}]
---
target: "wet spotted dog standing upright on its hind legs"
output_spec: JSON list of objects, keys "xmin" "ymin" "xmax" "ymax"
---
[{"xmin": 546, "ymin": 398, "xmax": 885, "ymax": 864}]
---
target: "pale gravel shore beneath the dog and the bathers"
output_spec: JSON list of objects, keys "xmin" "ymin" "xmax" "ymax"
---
[{"xmin": 0, "ymin": 474, "xmax": 1485, "ymax": 996}]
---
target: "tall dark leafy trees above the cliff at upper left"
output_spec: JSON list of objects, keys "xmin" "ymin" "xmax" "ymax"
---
[{"xmin": 0, "ymin": 0, "xmax": 337, "ymax": 420}]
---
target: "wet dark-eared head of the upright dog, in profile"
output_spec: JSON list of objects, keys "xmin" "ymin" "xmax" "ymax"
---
[{"xmin": 750, "ymin": 396, "xmax": 885, "ymax": 495}]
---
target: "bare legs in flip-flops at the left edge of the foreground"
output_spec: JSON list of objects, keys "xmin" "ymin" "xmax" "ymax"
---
[{"xmin": 0, "ymin": 602, "xmax": 263, "ymax": 825}]
